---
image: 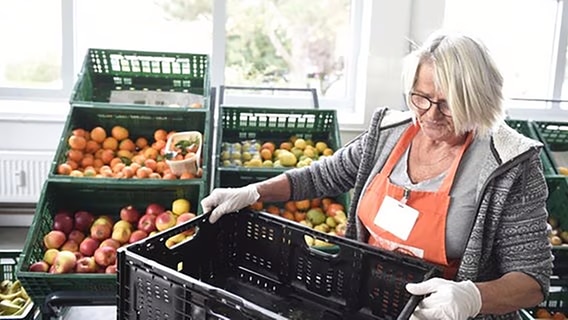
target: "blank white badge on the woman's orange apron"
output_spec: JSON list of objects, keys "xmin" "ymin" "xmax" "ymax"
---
[{"xmin": 373, "ymin": 196, "xmax": 419, "ymax": 241}]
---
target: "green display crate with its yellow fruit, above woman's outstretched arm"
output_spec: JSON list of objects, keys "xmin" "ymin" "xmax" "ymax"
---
[{"xmin": 214, "ymin": 106, "xmax": 341, "ymax": 187}]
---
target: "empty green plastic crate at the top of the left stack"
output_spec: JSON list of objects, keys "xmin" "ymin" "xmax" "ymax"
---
[{"xmin": 70, "ymin": 48, "xmax": 209, "ymax": 106}]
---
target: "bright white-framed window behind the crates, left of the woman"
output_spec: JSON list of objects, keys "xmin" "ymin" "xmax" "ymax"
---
[{"xmin": 0, "ymin": 0, "xmax": 362, "ymax": 115}]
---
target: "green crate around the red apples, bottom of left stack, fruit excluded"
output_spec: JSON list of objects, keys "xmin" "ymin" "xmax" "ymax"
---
[{"xmin": 17, "ymin": 180, "xmax": 205, "ymax": 304}]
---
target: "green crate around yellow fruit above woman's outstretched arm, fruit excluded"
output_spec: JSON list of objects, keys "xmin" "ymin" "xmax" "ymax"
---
[{"xmin": 215, "ymin": 106, "xmax": 341, "ymax": 187}]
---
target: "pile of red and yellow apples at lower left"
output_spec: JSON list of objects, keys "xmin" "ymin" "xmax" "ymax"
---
[{"xmin": 29, "ymin": 198, "xmax": 195, "ymax": 274}]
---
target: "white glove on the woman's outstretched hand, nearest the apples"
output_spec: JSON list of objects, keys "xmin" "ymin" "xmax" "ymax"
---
[{"xmin": 201, "ymin": 185, "xmax": 260, "ymax": 223}]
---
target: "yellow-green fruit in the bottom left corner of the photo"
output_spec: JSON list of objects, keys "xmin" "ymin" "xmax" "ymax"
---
[{"xmin": 0, "ymin": 280, "xmax": 32, "ymax": 319}]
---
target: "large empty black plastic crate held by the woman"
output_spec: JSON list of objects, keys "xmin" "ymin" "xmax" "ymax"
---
[{"xmin": 118, "ymin": 210, "xmax": 441, "ymax": 320}]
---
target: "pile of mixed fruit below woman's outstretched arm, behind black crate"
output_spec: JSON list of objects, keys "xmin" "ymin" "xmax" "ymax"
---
[{"xmin": 250, "ymin": 198, "xmax": 347, "ymax": 247}]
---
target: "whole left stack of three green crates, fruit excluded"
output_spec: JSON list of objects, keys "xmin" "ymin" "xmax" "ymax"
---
[{"xmin": 18, "ymin": 49, "xmax": 215, "ymax": 305}]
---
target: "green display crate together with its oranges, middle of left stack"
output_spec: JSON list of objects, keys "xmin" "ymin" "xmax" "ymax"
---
[{"xmin": 49, "ymin": 104, "xmax": 213, "ymax": 186}]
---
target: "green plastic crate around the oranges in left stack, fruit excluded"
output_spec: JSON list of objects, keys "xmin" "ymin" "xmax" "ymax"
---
[{"xmin": 49, "ymin": 104, "xmax": 213, "ymax": 186}]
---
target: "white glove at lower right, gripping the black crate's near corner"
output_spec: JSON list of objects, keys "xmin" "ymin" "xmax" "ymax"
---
[{"xmin": 406, "ymin": 278, "xmax": 481, "ymax": 320}]
